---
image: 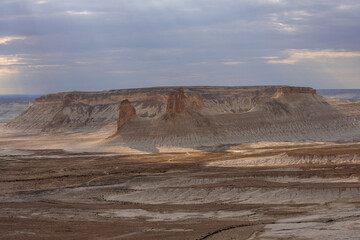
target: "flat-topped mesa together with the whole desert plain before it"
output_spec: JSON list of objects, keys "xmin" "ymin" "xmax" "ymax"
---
[{"xmin": 0, "ymin": 86, "xmax": 360, "ymax": 240}]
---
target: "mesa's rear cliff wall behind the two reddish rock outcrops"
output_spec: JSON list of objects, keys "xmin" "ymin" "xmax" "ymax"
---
[{"xmin": 8, "ymin": 86, "xmax": 286, "ymax": 131}]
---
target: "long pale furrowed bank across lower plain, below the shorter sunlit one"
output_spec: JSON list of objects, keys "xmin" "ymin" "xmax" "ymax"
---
[{"xmin": 104, "ymin": 186, "xmax": 360, "ymax": 205}]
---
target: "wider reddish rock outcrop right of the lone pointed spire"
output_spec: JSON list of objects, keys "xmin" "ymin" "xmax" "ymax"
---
[{"xmin": 166, "ymin": 88, "xmax": 205, "ymax": 114}]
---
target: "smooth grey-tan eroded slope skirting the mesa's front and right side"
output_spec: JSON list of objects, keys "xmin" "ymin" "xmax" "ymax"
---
[{"xmin": 113, "ymin": 89, "xmax": 360, "ymax": 151}]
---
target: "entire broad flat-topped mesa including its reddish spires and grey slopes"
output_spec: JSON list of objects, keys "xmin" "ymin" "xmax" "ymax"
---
[{"xmin": 8, "ymin": 86, "xmax": 360, "ymax": 148}]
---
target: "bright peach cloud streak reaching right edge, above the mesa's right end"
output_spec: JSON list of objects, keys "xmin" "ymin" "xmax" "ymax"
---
[{"xmin": 263, "ymin": 49, "xmax": 360, "ymax": 64}]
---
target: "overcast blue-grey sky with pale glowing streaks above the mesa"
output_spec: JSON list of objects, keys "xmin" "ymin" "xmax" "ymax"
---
[{"xmin": 0, "ymin": 0, "xmax": 360, "ymax": 94}]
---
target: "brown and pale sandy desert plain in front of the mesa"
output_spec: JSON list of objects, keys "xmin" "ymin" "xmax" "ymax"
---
[{"xmin": 0, "ymin": 128, "xmax": 360, "ymax": 240}]
